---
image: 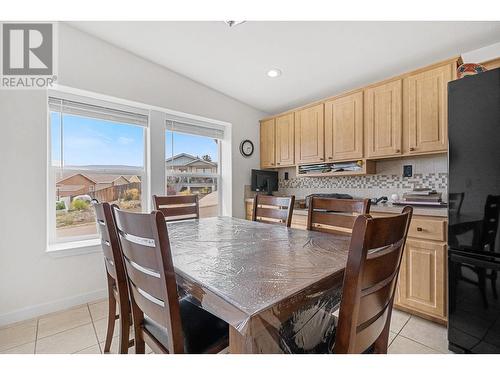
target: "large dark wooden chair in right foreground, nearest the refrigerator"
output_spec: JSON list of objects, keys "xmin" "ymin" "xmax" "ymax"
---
[{"xmin": 280, "ymin": 207, "xmax": 413, "ymax": 354}]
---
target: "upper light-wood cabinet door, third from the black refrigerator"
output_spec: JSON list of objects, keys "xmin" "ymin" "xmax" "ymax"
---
[{"xmin": 325, "ymin": 92, "xmax": 363, "ymax": 161}]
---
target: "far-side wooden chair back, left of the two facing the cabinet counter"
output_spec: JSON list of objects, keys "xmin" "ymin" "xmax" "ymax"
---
[{"xmin": 252, "ymin": 194, "xmax": 295, "ymax": 227}]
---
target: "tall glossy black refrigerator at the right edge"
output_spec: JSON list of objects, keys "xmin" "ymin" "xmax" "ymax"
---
[{"xmin": 448, "ymin": 69, "xmax": 500, "ymax": 353}]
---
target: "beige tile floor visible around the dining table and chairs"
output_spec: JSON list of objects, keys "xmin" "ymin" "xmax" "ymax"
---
[{"xmin": 0, "ymin": 300, "xmax": 449, "ymax": 354}]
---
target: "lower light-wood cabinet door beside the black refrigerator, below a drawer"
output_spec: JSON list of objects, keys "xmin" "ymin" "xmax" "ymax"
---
[{"xmin": 398, "ymin": 239, "xmax": 446, "ymax": 318}]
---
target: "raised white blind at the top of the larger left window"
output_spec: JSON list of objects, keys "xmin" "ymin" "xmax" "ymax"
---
[{"xmin": 49, "ymin": 97, "xmax": 148, "ymax": 126}]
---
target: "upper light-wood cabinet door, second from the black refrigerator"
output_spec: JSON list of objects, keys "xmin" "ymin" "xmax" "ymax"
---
[{"xmin": 364, "ymin": 79, "xmax": 403, "ymax": 157}]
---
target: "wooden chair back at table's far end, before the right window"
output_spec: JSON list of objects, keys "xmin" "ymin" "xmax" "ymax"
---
[{"xmin": 153, "ymin": 194, "xmax": 200, "ymax": 221}]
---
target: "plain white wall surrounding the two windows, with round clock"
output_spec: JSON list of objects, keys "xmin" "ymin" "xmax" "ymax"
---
[{"xmin": 0, "ymin": 24, "xmax": 265, "ymax": 325}]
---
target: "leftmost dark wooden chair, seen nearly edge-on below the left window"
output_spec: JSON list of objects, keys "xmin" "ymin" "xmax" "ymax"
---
[{"xmin": 93, "ymin": 201, "xmax": 134, "ymax": 354}]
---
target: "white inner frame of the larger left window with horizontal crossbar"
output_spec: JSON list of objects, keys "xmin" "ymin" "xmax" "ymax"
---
[{"xmin": 47, "ymin": 90, "xmax": 150, "ymax": 251}]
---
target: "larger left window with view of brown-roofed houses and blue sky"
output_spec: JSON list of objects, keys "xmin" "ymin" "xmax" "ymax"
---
[{"xmin": 49, "ymin": 97, "xmax": 148, "ymax": 243}]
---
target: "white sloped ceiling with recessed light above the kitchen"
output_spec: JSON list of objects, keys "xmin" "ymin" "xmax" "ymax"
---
[{"xmin": 70, "ymin": 21, "xmax": 500, "ymax": 113}]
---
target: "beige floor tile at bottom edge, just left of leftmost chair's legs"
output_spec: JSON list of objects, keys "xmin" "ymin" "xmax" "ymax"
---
[{"xmin": 36, "ymin": 324, "xmax": 98, "ymax": 354}]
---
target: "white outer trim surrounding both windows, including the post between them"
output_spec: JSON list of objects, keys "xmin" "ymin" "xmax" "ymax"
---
[{"xmin": 45, "ymin": 84, "xmax": 234, "ymax": 258}]
